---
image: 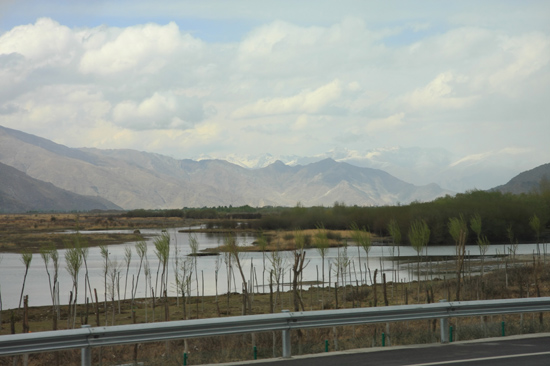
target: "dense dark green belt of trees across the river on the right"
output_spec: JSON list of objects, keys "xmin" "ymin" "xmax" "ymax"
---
[{"xmin": 205, "ymin": 190, "xmax": 550, "ymax": 245}]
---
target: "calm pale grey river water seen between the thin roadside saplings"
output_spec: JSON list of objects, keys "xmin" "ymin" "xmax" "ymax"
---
[{"xmin": 0, "ymin": 229, "xmax": 547, "ymax": 309}]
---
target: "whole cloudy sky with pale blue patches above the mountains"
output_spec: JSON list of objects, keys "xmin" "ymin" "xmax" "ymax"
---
[{"xmin": 0, "ymin": 0, "xmax": 550, "ymax": 172}]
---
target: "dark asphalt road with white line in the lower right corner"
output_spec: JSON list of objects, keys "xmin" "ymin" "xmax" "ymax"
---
[{"xmin": 222, "ymin": 334, "xmax": 550, "ymax": 366}]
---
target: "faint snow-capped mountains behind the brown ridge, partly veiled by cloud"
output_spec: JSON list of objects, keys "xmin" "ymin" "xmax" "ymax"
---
[{"xmin": 213, "ymin": 147, "xmax": 529, "ymax": 192}]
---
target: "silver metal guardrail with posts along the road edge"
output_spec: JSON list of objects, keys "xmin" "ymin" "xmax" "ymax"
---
[{"xmin": 0, "ymin": 297, "xmax": 550, "ymax": 366}]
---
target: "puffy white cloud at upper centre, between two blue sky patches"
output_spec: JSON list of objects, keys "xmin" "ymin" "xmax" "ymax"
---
[{"xmin": 235, "ymin": 17, "xmax": 385, "ymax": 79}]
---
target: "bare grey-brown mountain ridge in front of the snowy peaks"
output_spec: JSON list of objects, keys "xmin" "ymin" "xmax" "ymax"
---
[{"xmin": 0, "ymin": 127, "xmax": 452, "ymax": 209}]
